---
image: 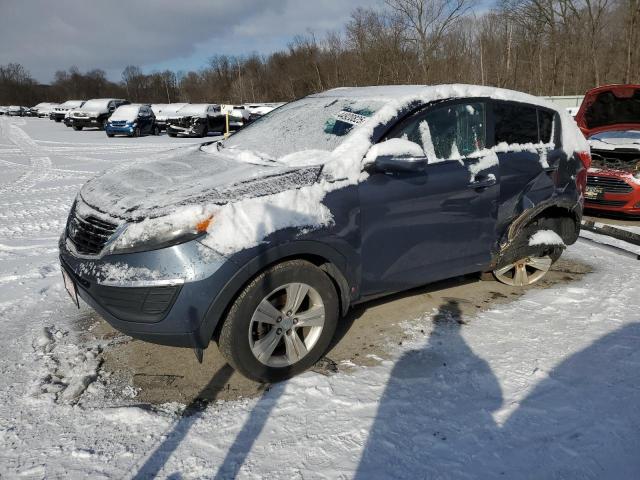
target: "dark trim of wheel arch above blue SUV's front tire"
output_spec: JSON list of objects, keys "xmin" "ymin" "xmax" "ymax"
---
[{"xmin": 197, "ymin": 241, "xmax": 351, "ymax": 347}]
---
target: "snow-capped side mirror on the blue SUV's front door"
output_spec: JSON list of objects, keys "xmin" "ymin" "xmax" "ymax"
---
[{"xmin": 367, "ymin": 138, "xmax": 428, "ymax": 172}]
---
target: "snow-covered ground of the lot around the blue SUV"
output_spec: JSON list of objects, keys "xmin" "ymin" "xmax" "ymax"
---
[{"xmin": 0, "ymin": 117, "xmax": 640, "ymax": 479}]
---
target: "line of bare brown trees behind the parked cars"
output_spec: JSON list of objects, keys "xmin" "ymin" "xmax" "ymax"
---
[{"xmin": 0, "ymin": 0, "xmax": 640, "ymax": 105}]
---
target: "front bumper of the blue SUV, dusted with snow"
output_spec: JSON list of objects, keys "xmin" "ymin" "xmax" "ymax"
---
[{"xmin": 59, "ymin": 235, "xmax": 238, "ymax": 348}]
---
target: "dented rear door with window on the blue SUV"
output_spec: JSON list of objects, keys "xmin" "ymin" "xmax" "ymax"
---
[{"xmin": 491, "ymin": 100, "xmax": 568, "ymax": 233}]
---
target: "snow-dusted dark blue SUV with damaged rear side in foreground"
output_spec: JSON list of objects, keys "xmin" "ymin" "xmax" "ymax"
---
[{"xmin": 59, "ymin": 85, "xmax": 590, "ymax": 382}]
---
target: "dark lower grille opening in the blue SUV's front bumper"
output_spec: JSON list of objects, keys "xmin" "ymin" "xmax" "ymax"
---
[{"xmin": 93, "ymin": 285, "xmax": 181, "ymax": 323}]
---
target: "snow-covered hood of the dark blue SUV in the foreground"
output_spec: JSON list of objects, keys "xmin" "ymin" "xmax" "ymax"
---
[{"xmin": 80, "ymin": 146, "xmax": 322, "ymax": 221}]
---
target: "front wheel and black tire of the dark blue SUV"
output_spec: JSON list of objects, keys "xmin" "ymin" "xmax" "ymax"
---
[{"xmin": 218, "ymin": 260, "xmax": 339, "ymax": 382}]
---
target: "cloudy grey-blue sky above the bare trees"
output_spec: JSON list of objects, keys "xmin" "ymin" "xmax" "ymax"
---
[{"xmin": 0, "ymin": 0, "xmax": 382, "ymax": 83}]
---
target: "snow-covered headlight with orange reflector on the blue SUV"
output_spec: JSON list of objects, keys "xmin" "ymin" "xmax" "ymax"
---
[{"xmin": 109, "ymin": 216, "xmax": 213, "ymax": 253}]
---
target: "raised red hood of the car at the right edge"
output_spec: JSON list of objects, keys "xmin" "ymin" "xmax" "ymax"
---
[{"xmin": 576, "ymin": 85, "xmax": 640, "ymax": 138}]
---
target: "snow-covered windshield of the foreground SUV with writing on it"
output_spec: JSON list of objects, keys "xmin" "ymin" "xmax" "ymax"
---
[{"xmin": 224, "ymin": 97, "xmax": 383, "ymax": 159}]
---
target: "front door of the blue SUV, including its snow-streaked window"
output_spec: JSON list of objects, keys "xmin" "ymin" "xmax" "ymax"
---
[{"xmin": 359, "ymin": 99, "xmax": 499, "ymax": 295}]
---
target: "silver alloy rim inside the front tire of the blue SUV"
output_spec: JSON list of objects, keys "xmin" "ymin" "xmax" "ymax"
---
[{"xmin": 249, "ymin": 283, "xmax": 325, "ymax": 367}]
